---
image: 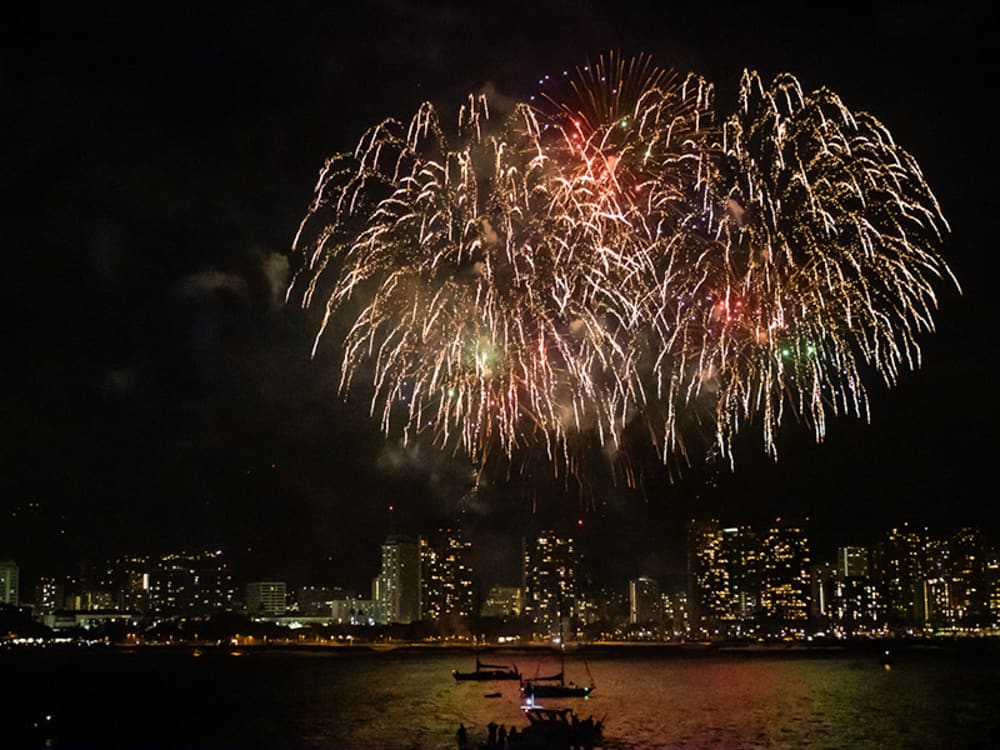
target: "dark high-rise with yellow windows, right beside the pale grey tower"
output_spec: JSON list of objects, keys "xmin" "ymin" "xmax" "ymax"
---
[{"xmin": 420, "ymin": 529, "xmax": 474, "ymax": 620}]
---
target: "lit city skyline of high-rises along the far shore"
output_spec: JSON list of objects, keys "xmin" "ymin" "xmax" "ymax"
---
[{"xmin": 0, "ymin": 518, "xmax": 1000, "ymax": 644}]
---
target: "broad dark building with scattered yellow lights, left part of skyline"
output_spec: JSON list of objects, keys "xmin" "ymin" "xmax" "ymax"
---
[{"xmin": 149, "ymin": 551, "xmax": 236, "ymax": 615}]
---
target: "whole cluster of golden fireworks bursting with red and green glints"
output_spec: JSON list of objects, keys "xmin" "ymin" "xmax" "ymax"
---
[{"xmin": 289, "ymin": 55, "xmax": 954, "ymax": 488}]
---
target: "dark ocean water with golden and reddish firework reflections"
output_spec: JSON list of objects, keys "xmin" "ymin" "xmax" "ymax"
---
[{"xmin": 0, "ymin": 643, "xmax": 1000, "ymax": 750}]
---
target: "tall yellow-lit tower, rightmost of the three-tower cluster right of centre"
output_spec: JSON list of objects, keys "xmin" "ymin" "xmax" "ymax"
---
[{"xmin": 760, "ymin": 518, "xmax": 810, "ymax": 635}]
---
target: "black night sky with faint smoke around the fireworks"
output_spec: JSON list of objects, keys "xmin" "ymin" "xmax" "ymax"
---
[{"xmin": 0, "ymin": 0, "xmax": 1000, "ymax": 591}]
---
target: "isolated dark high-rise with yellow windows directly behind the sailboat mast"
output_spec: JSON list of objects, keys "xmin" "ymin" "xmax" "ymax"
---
[{"xmin": 522, "ymin": 531, "xmax": 577, "ymax": 635}]
